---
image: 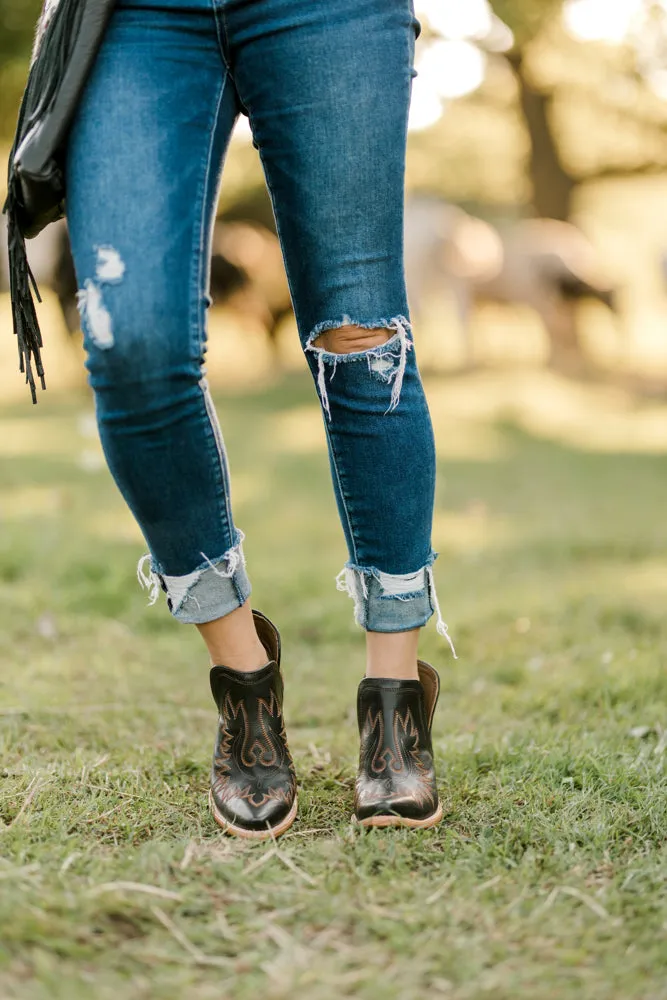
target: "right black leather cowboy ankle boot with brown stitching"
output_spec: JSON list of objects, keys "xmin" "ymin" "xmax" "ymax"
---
[{"xmin": 354, "ymin": 660, "xmax": 442, "ymax": 827}]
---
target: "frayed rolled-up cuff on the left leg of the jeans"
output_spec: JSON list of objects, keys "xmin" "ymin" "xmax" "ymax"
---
[{"xmin": 137, "ymin": 530, "xmax": 252, "ymax": 625}]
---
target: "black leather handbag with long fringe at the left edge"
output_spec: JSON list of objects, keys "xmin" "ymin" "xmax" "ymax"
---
[{"xmin": 3, "ymin": 0, "xmax": 115, "ymax": 403}]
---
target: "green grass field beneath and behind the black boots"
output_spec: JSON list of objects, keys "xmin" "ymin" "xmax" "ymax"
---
[{"xmin": 0, "ymin": 375, "xmax": 667, "ymax": 1000}]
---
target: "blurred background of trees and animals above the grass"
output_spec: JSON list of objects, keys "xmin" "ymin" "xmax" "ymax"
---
[{"xmin": 0, "ymin": 0, "xmax": 667, "ymax": 399}]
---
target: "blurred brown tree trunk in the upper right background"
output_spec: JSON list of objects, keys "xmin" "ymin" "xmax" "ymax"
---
[{"xmin": 507, "ymin": 50, "xmax": 575, "ymax": 222}]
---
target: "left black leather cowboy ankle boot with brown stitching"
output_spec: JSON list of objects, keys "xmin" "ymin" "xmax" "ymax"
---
[{"xmin": 210, "ymin": 611, "xmax": 296, "ymax": 840}]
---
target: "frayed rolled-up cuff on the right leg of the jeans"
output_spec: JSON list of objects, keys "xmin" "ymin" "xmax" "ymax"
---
[{"xmin": 336, "ymin": 553, "xmax": 456, "ymax": 659}]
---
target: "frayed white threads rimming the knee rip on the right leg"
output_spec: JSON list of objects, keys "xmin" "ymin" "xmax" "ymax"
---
[{"xmin": 305, "ymin": 316, "xmax": 413, "ymax": 420}]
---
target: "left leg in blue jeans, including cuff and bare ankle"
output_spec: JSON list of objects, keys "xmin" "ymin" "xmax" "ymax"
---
[{"xmin": 68, "ymin": 0, "xmax": 266, "ymax": 669}]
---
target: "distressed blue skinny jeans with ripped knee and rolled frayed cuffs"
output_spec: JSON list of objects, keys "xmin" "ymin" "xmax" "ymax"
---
[{"xmin": 67, "ymin": 0, "xmax": 452, "ymax": 632}]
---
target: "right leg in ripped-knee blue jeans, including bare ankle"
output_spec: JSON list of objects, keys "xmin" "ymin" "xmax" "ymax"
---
[{"xmin": 222, "ymin": 0, "xmax": 454, "ymax": 678}]
